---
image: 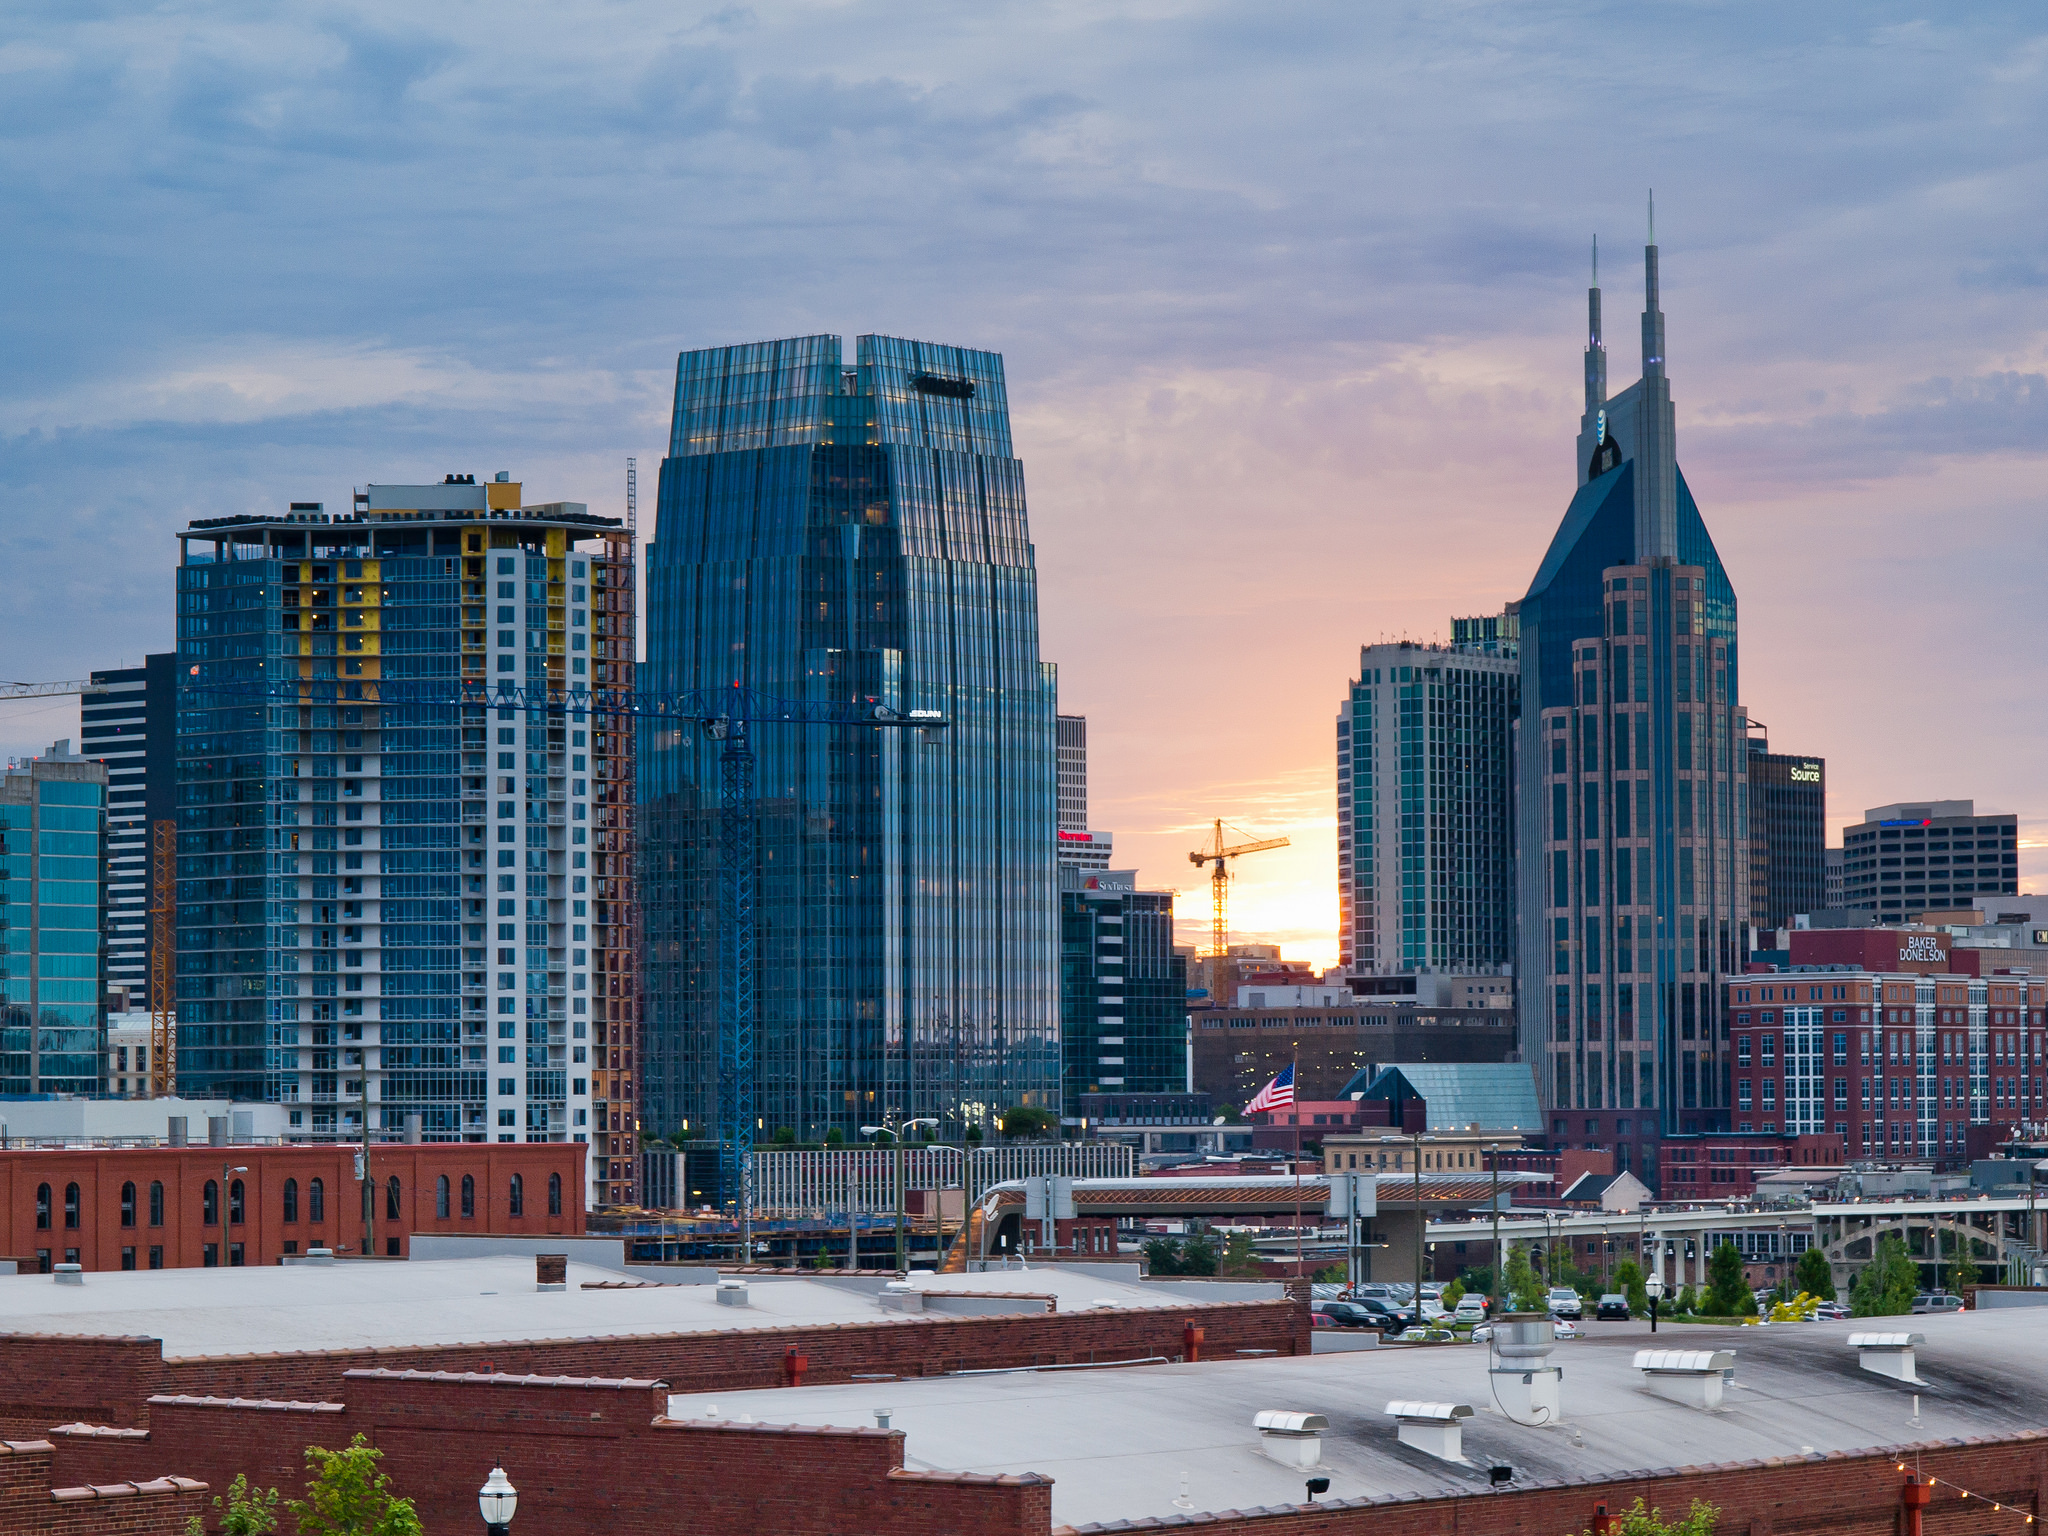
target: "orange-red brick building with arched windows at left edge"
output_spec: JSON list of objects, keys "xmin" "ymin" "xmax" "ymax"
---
[{"xmin": 0, "ymin": 1141, "xmax": 590, "ymax": 1270}]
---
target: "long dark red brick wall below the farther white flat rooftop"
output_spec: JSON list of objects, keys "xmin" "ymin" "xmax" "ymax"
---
[{"xmin": 0, "ymin": 1300, "xmax": 1309, "ymax": 1434}]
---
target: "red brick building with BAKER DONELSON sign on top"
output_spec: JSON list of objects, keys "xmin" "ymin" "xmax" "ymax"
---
[{"xmin": 1728, "ymin": 928, "xmax": 2048, "ymax": 1163}]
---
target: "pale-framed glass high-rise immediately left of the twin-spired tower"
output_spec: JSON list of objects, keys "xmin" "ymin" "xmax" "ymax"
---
[{"xmin": 1337, "ymin": 641, "xmax": 1520, "ymax": 975}]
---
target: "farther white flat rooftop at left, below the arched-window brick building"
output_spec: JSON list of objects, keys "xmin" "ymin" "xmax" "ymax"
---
[{"xmin": 0, "ymin": 1255, "xmax": 1212, "ymax": 1358}]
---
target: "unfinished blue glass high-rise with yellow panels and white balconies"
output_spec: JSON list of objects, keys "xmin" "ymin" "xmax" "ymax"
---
[{"xmin": 176, "ymin": 475, "xmax": 639, "ymax": 1204}]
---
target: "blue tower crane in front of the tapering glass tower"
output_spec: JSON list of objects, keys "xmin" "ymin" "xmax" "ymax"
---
[{"xmin": 180, "ymin": 668, "xmax": 937, "ymax": 1257}]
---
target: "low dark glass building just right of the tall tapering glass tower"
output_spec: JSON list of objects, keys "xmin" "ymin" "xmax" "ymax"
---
[{"xmin": 1059, "ymin": 868, "xmax": 1188, "ymax": 1120}]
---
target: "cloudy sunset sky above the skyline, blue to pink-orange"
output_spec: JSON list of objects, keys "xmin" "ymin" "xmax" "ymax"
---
[{"xmin": 0, "ymin": 0, "xmax": 2048, "ymax": 963}]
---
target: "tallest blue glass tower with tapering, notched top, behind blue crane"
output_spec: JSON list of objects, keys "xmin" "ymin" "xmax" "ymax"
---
[{"xmin": 639, "ymin": 336, "xmax": 1059, "ymax": 1141}]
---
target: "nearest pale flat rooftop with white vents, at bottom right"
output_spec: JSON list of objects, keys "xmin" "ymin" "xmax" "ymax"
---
[{"xmin": 670, "ymin": 1307, "xmax": 2048, "ymax": 1526}]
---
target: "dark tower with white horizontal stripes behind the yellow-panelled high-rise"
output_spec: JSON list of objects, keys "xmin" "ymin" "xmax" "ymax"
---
[{"xmin": 78, "ymin": 651, "xmax": 178, "ymax": 1010}]
